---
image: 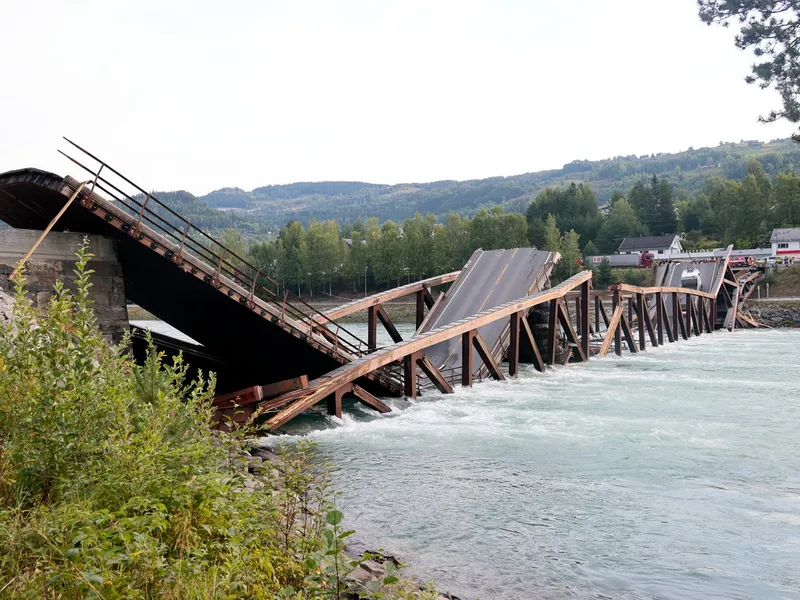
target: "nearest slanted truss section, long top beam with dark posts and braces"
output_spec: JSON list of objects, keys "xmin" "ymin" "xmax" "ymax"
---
[{"xmin": 265, "ymin": 271, "xmax": 592, "ymax": 430}]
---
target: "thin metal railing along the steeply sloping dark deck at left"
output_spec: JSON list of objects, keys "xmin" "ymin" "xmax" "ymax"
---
[{"xmin": 59, "ymin": 138, "xmax": 376, "ymax": 357}]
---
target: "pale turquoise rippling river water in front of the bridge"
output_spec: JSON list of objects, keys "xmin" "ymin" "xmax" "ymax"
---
[{"xmin": 288, "ymin": 331, "xmax": 800, "ymax": 599}]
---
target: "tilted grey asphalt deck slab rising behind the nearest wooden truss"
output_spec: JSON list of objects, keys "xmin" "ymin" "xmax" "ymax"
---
[{"xmin": 420, "ymin": 248, "xmax": 552, "ymax": 376}]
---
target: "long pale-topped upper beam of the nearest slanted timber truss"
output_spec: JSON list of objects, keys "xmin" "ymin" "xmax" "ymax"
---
[{"xmin": 265, "ymin": 271, "xmax": 592, "ymax": 430}]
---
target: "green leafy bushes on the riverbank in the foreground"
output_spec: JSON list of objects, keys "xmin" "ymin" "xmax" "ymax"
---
[{"xmin": 0, "ymin": 245, "xmax": 432, "ymax": 600}]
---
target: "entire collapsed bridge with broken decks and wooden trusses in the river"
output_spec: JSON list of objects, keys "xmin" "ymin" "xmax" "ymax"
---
[{"xmin": 0, "ymin": 142, "xmax": 759, "ymax": 430}]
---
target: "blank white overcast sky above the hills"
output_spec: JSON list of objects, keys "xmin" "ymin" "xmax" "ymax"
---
[{"xmin": 0, "ymin": 0, "xmax": 793, "ymax": 194}]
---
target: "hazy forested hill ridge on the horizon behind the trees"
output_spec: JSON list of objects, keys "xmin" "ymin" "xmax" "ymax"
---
[{"xmin": 153, "ymin": 139, "xmax": 800, "ymax": 233}]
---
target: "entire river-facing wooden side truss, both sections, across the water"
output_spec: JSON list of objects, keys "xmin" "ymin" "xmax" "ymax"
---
[{"xmin": 245, "ymin": 261, "xmax": 760, "ymax": 431}]
